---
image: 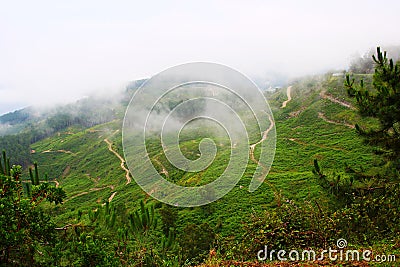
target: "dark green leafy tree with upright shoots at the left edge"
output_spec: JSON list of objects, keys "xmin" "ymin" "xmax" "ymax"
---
[{"xmin": 0, "ymin": 153, "xmax": 65, "ymax": 266}]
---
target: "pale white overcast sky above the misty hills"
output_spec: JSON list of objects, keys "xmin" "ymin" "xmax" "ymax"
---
[{"xmin": 0, "ymin": 0, "xmax": 400, "ymax": 114}]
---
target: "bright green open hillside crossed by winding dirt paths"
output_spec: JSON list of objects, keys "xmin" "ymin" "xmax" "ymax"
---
[{"xmin": 27, "ymin": 76, "xmax": 373, "ymax": 232}]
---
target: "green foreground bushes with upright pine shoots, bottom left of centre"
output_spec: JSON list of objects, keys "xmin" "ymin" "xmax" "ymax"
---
[{"xmin": 52, "ymin": 202, "xmax": 181, "ymax": 266}]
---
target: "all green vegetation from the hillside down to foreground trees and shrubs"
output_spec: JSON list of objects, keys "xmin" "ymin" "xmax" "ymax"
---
[{"xmin": 0, "ymin": 50, "xmax": 400, "ymax": 266}]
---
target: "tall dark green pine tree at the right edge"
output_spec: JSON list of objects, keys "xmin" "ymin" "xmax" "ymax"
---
[{"xmin": 345, "ymin": 47, "xmax": 400, "ymax": 170}]
